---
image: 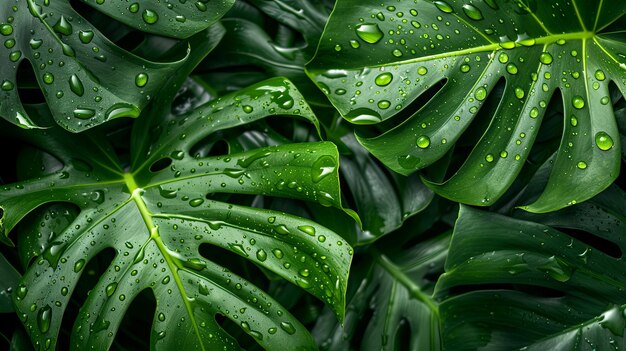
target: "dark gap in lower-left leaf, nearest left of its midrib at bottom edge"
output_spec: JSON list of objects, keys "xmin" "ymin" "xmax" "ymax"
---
[{"xmin": 113, "ymin": 288, "xmax": 154, "ymax": 350}]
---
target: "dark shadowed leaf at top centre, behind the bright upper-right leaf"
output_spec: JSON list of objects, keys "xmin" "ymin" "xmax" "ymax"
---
[{"xmin": 196, "ymin": 0, "xmax": 330, "ymax": 105}]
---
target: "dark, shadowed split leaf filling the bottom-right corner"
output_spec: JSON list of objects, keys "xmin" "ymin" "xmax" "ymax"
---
[{"xmin": 435, "ymin": 186, "xmax": 626, "ymax": 351}]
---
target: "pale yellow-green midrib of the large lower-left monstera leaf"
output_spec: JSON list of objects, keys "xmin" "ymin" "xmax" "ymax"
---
[{"xmin": 124, "ymin": 173, "xmax": 205, "ymax": 351}]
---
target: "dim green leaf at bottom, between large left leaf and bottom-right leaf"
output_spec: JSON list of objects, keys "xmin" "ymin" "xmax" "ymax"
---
[{"xmin": 313, "ymin": 232, "xmax": 451, "ymax": 351}]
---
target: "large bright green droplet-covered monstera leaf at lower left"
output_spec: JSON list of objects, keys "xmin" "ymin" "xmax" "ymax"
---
[{"xmin": 0, "ymin": 78, "xmax": 352, "ymax": 350}]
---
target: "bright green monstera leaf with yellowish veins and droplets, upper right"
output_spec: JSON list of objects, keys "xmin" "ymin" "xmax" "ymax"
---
[{"xmin": 307, "ymin": 0, "xmax": 626, "ymax": 212}]
